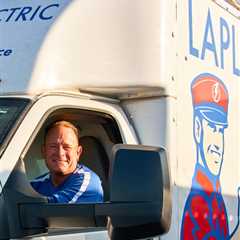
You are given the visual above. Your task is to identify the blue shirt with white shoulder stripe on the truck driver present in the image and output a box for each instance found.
[31,165,103,203]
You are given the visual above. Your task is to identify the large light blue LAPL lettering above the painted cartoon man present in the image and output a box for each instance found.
[188,0,240,76]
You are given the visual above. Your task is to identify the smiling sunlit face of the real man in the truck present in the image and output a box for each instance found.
[43,126,82,175]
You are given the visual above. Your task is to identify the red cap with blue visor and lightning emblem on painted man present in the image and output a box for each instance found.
[191,74,228,125]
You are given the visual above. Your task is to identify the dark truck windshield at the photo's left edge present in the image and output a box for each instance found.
[0,98,30,148]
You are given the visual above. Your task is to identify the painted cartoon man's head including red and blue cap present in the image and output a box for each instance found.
[191,74,228,176]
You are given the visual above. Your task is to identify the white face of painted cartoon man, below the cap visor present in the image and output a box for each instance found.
[202,119,224,175]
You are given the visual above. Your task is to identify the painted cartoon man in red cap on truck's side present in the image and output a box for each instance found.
[181,74,230,240]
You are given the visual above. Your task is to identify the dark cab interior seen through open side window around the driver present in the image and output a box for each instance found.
[23,108,122,201]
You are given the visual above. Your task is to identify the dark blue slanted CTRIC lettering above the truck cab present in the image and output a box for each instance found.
[0,3,60,22]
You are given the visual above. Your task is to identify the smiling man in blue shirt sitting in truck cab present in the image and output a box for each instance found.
[31,121,103,203]
